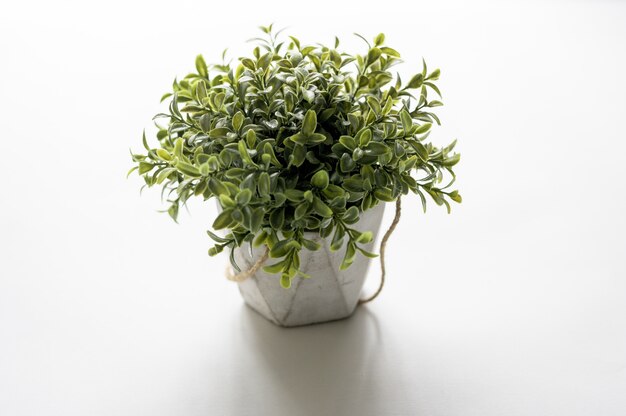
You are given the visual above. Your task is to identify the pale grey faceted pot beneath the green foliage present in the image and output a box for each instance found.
[235,203,385,327]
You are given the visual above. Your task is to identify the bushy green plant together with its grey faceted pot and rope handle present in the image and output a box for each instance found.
[131,25,461,326]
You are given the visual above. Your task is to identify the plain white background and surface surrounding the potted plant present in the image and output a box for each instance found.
[0,0,626,416]
